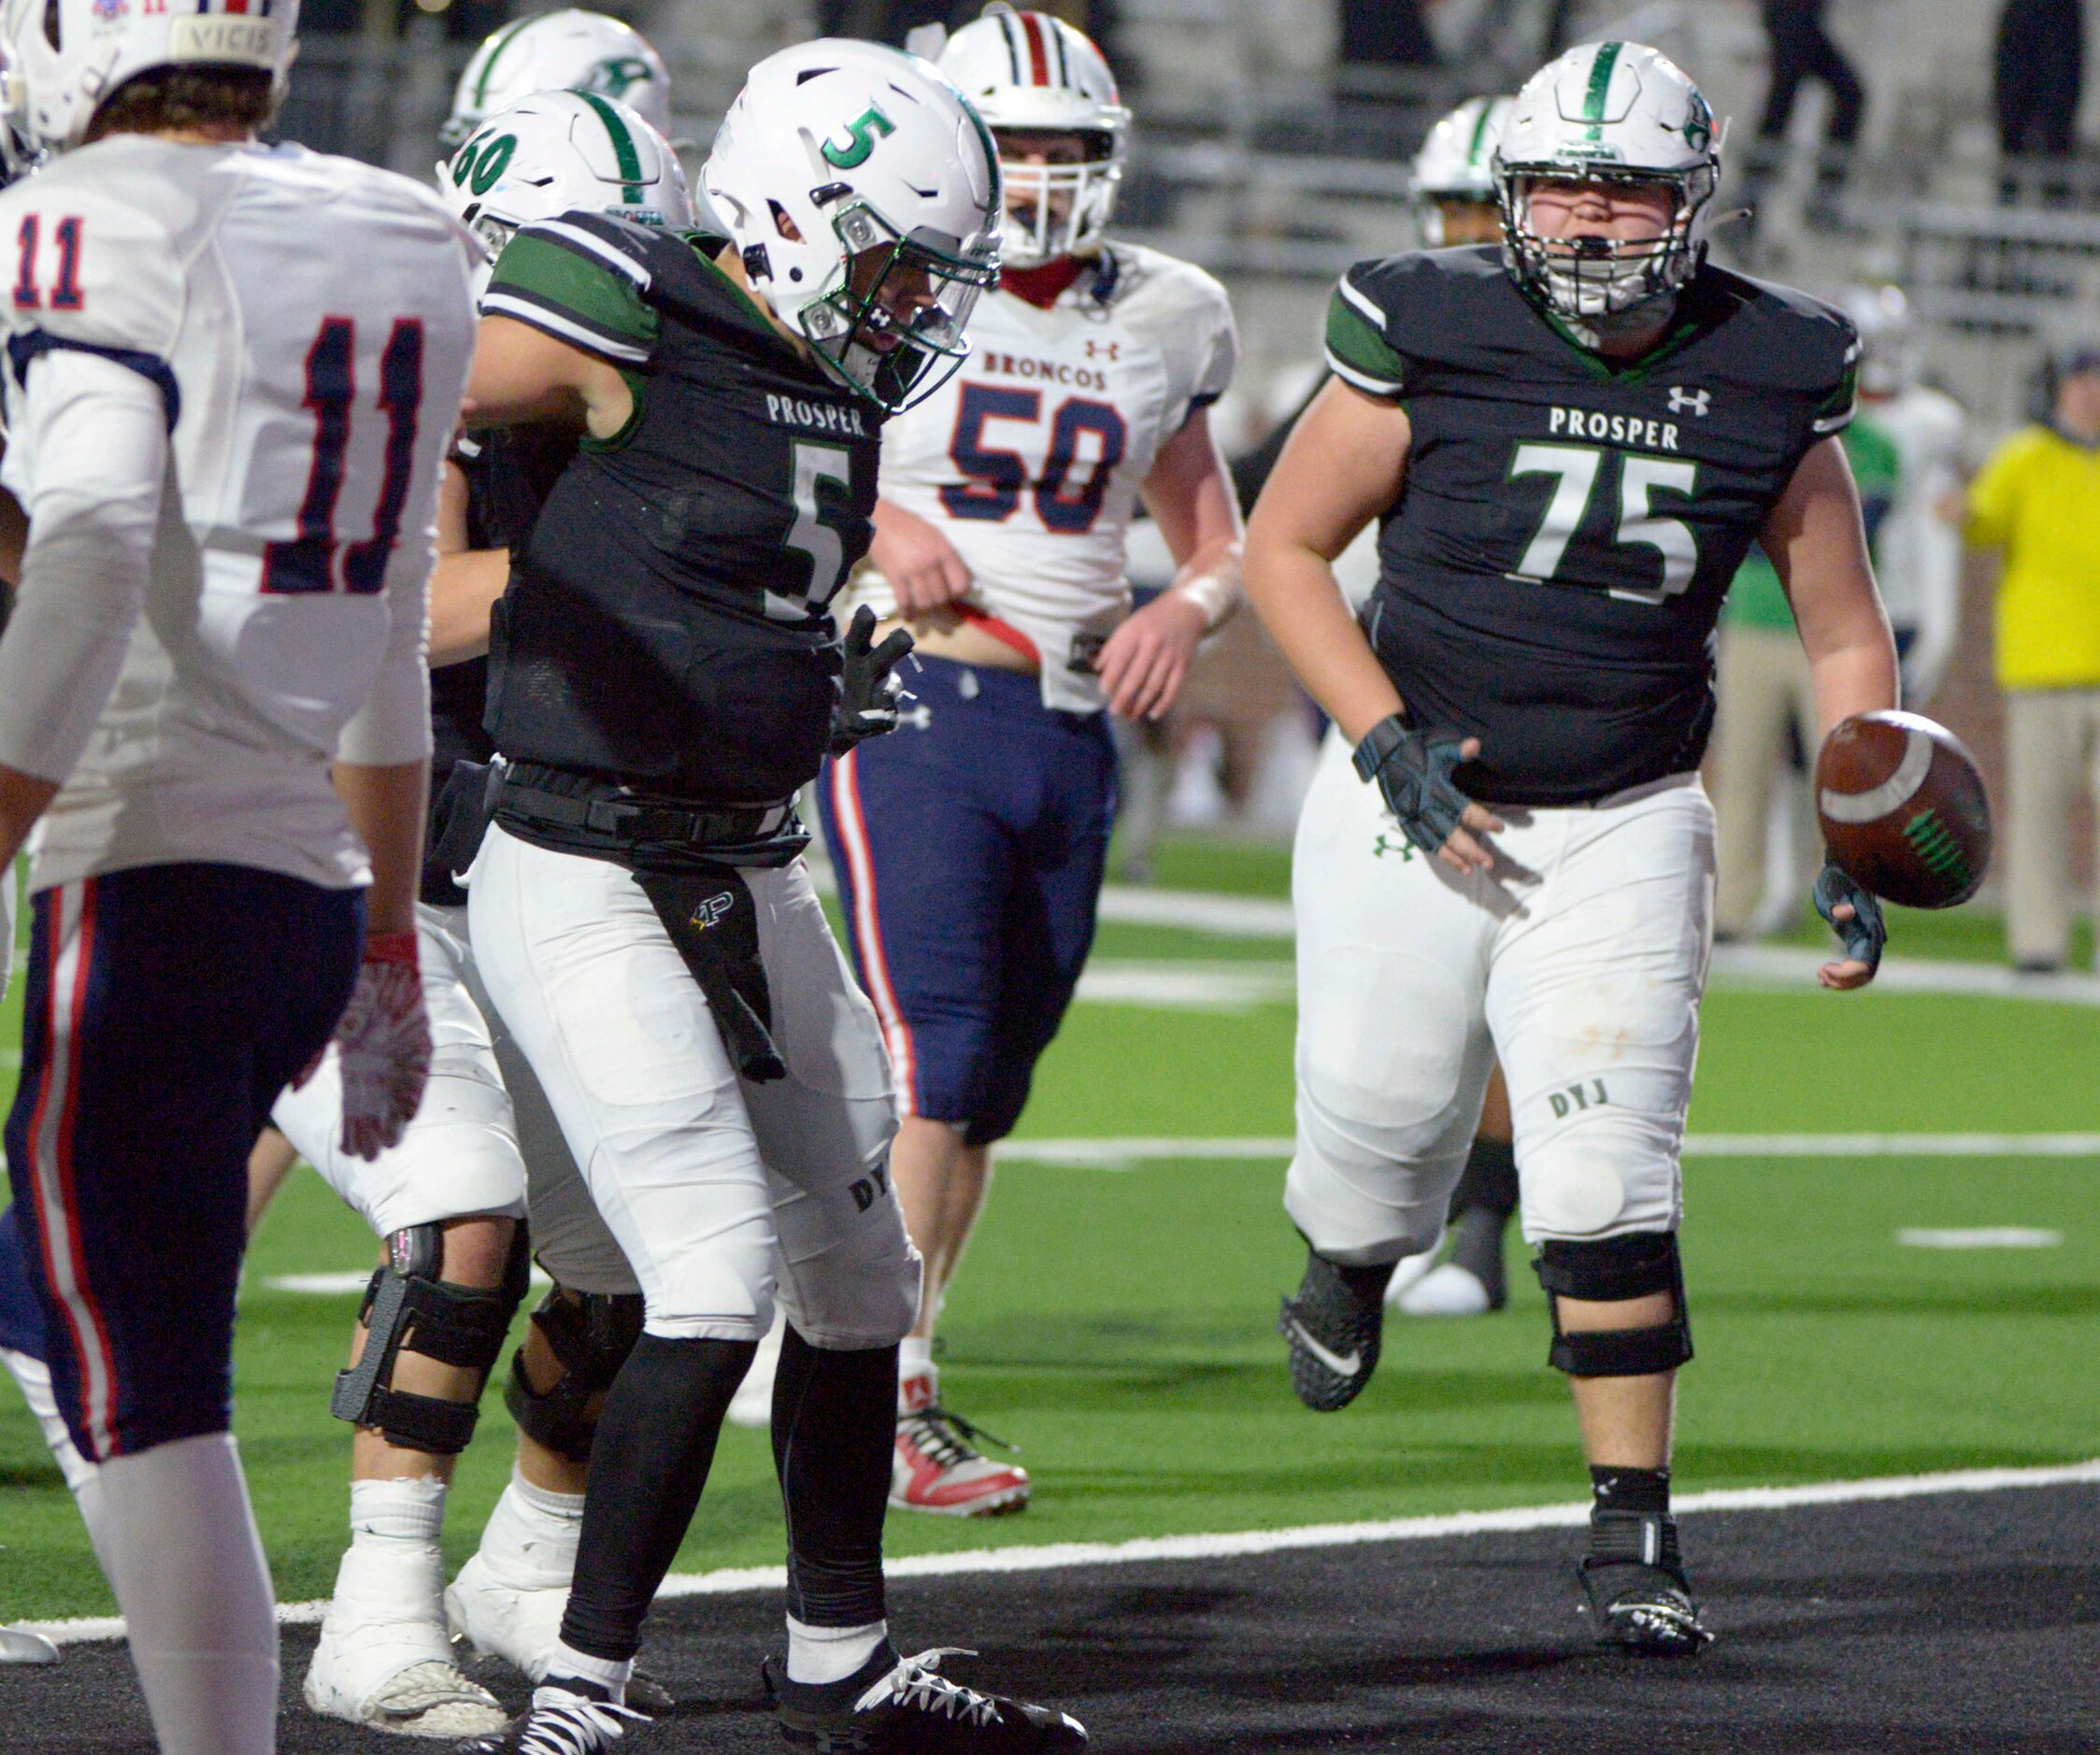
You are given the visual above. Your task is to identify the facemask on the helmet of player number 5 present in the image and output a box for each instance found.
[797,197,1000,414]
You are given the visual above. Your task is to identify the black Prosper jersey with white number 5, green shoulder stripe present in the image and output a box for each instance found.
[481,212,879,802]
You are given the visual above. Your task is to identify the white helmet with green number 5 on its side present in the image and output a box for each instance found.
[699,37,1000,414]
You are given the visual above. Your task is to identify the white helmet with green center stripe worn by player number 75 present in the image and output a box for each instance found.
[1495,42,1720,321]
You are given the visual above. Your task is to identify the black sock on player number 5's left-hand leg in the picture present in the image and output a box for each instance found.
[561,1333,758,1662]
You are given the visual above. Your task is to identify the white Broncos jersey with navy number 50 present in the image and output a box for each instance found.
[857,244,1239,712]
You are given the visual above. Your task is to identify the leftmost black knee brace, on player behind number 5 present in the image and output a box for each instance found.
[328,1224,531,1457]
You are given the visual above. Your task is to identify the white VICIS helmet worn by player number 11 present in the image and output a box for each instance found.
[0,0,298,153]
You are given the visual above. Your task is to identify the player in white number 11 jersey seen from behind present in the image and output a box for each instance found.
[0,0,473,1755]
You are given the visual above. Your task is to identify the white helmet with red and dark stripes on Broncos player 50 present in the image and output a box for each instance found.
[938,4,1130,269]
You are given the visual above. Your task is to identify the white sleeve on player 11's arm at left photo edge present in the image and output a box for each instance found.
[0,349,168,785]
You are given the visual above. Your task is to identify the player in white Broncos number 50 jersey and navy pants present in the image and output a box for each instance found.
[819,8,1239,1516]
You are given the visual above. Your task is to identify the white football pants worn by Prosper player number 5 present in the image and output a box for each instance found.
[468,825,920,1348]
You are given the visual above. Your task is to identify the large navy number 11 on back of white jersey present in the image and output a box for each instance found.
[263,317,422,596]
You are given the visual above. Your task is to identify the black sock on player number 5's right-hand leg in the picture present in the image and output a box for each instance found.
[773,1322,896,1627]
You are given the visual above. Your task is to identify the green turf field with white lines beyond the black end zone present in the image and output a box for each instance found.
[0,844,2100,1619]
